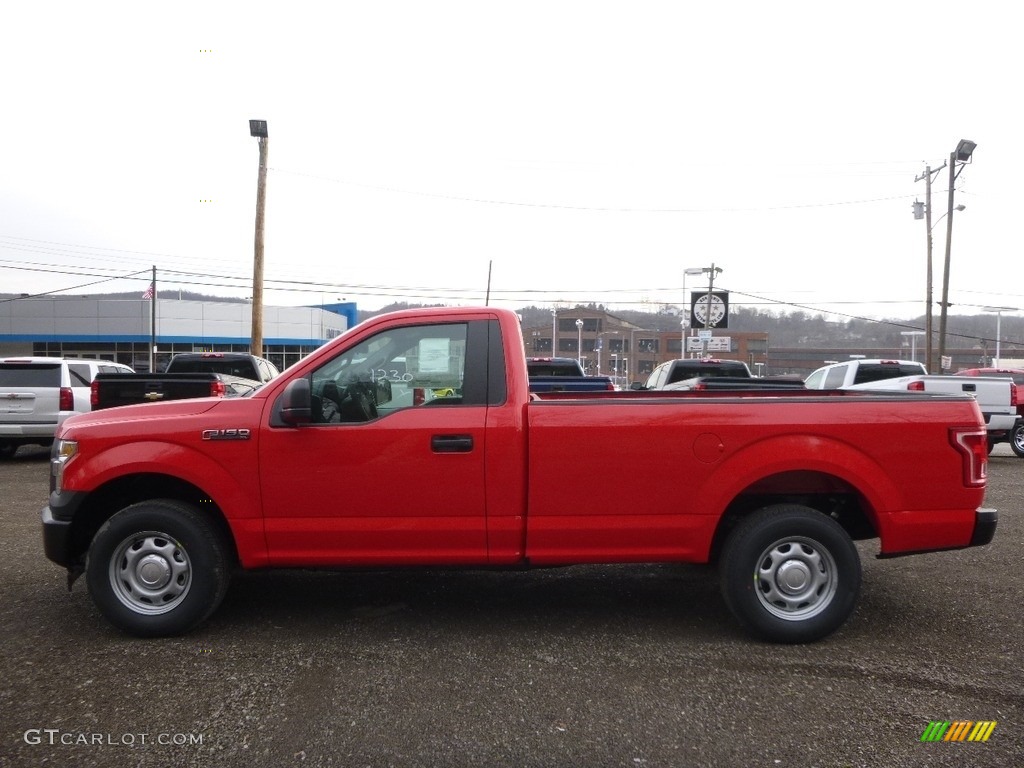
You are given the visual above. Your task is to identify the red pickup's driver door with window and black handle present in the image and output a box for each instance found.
[259,322,487,565]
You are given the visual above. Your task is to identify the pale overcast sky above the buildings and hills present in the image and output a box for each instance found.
[0,0,1024,317]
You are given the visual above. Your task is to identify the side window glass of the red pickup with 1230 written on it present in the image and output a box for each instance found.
[310,324,466,424]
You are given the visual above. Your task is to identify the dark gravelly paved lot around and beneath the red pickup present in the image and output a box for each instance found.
[0,445,1024,768]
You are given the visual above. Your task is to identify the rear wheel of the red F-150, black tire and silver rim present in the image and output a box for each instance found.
[719,504,860,643]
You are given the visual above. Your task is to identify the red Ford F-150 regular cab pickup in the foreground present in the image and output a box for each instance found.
[43,308,997,642]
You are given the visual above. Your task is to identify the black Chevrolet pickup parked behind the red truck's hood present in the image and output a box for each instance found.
[90,352,279,411]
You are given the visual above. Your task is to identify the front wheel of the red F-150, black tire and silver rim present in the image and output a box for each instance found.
[86,499,230,637]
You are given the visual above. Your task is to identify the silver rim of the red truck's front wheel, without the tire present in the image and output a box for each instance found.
[110,530,191,615]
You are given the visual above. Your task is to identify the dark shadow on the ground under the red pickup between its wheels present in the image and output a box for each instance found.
[214,564,739,639]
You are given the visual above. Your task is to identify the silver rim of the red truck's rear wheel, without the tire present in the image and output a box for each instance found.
[754,537,839,622]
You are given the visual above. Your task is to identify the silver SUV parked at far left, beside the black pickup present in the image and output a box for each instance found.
[0,357,133,459]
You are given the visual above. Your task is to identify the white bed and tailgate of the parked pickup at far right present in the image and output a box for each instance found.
[844,376,1020,451]
